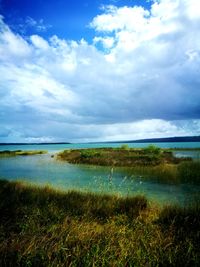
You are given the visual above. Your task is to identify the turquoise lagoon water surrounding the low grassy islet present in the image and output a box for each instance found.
[0,143,200,207]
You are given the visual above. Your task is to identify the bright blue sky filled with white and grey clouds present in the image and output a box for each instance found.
[0,0,200,142]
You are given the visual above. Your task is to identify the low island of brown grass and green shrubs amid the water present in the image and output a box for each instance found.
[58,145,191,167]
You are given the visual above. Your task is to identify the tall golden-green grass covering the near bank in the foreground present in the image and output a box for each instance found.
[0,181,200,266]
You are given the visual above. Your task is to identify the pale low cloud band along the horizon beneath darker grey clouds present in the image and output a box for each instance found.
[0,117,200,142]
